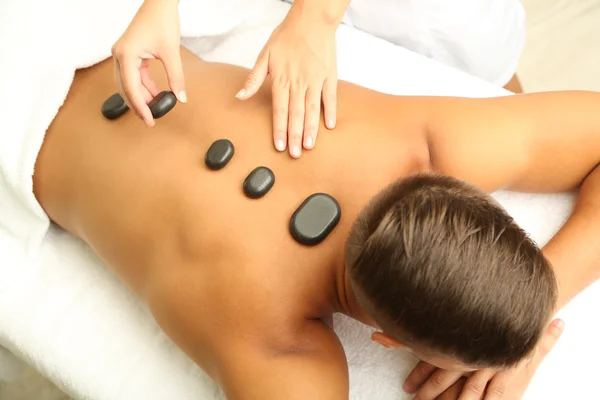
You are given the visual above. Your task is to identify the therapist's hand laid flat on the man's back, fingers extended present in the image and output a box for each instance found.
[236,7,337,158]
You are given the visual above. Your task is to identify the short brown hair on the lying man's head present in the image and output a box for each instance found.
[346,174,557,367]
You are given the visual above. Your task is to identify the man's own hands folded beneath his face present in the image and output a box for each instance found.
[404,319,564,400]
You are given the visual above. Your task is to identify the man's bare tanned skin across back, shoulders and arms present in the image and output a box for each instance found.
[34,49,600,400]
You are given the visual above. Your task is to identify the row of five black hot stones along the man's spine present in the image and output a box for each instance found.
[102,91,341,246]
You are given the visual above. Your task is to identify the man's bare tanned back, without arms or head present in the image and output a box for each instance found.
[35,47,427,394]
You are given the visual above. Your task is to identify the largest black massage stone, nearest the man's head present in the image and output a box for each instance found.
[290,193,342,246]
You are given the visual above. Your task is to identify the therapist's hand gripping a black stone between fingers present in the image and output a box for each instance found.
[112,0,187,126]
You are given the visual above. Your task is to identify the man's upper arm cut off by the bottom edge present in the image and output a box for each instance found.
[218,322,349,400]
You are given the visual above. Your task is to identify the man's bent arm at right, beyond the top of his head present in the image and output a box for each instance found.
[423,92,600,308]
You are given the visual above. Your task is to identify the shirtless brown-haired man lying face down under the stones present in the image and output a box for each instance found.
[34,49,600,400]
